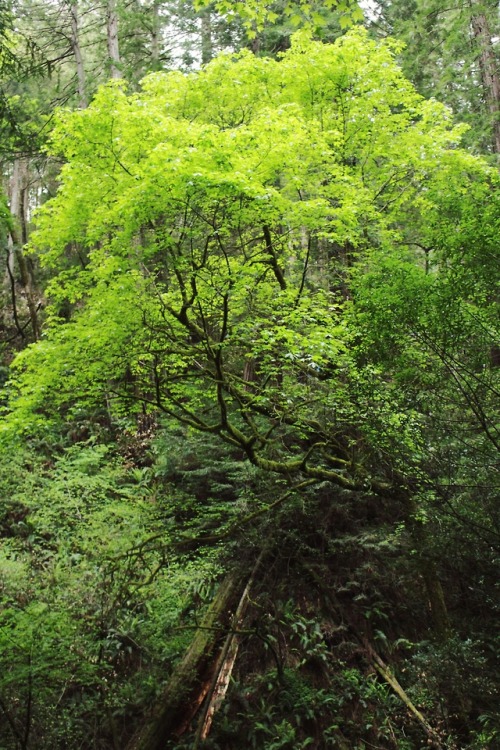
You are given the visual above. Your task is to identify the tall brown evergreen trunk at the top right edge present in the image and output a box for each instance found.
[471,2,500,154]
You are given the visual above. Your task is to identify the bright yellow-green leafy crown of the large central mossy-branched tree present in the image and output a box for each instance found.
[4,31,480,484]
